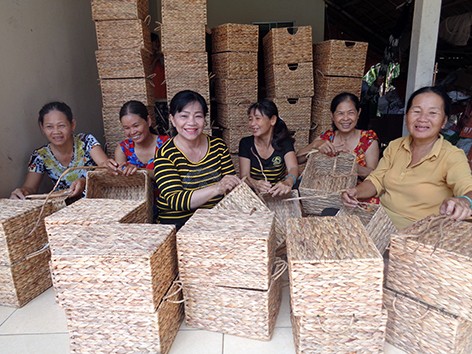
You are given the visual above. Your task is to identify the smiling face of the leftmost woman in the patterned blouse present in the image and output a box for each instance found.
[41,110,75,146]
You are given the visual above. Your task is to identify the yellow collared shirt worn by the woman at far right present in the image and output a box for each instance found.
[366,136,472,229]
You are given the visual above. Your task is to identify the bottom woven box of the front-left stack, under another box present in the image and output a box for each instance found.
[65,276,183,354]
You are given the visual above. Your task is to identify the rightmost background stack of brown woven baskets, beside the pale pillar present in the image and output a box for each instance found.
[310,40,367,141]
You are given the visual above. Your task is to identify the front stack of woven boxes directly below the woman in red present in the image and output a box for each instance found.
[287,216,387,354]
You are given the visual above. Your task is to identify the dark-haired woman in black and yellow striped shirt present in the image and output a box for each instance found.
[154,90,240,228]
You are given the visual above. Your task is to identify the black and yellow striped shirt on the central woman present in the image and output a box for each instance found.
[154,136,235,228]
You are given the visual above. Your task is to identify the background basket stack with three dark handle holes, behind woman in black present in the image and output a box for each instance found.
[263,26,313,149]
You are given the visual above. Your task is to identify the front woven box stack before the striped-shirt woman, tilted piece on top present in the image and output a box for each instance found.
[177,183,286,340]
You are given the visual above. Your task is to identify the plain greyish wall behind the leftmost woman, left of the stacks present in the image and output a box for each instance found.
[0,0,104,197]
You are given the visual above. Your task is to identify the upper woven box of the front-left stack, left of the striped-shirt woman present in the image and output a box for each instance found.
[48,224,178,313]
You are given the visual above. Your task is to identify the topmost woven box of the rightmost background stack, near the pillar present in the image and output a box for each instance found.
[313,40,368,77]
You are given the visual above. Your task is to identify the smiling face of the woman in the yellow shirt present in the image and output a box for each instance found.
[406,92,446,141]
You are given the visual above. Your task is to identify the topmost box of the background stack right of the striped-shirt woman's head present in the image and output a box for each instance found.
[211,23,259,53]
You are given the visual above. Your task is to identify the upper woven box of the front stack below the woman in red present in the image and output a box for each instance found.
[287,216,383,317]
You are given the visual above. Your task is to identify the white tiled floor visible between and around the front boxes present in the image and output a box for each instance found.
[0,287,404,354]
